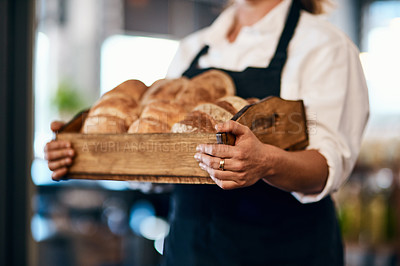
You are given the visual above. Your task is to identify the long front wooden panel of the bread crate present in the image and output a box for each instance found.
[57,133,217,180]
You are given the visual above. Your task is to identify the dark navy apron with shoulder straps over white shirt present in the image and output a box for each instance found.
[163,0,343,266]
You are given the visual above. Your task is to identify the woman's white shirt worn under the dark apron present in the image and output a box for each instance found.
[167,0,369,203]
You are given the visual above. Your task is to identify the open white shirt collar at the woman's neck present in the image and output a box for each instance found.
[204,0,292,46]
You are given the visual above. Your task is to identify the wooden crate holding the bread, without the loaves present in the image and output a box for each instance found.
[56,97,308,184]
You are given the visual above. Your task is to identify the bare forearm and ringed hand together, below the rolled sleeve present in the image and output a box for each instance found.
[195,121,329,194]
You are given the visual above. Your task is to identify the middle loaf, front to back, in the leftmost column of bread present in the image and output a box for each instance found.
[88,98,140,128]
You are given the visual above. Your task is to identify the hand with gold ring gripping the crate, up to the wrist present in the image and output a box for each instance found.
[194,120,280,189]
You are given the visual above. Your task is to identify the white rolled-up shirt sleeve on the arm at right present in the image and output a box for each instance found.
[292,39,369,203]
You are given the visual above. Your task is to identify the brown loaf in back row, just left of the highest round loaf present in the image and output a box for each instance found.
[142,77,189,105]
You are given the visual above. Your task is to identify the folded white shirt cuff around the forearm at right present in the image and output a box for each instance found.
[292,145,343,204]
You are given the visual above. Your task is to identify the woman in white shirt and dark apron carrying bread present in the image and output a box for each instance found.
[47,0,368,265]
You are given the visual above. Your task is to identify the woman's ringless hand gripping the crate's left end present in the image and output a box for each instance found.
[44,121,75,181]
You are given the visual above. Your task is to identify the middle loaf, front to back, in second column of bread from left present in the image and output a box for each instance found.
[140,100,186,127]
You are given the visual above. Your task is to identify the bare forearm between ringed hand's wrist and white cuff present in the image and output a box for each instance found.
[263,146,329,194]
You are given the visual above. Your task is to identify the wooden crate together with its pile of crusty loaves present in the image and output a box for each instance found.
[57,70,308,184]
